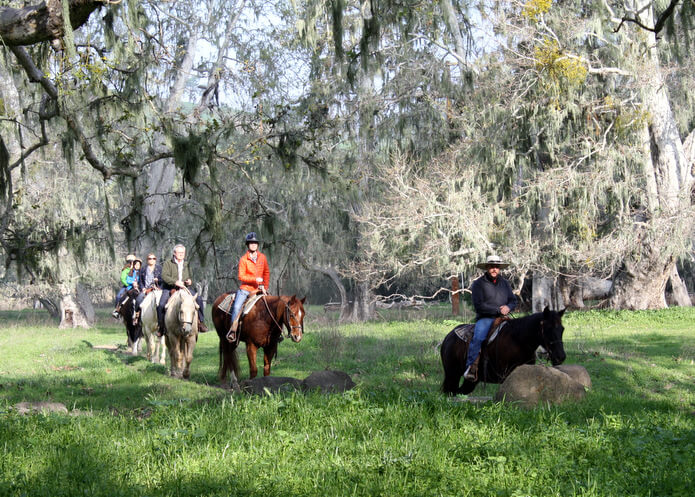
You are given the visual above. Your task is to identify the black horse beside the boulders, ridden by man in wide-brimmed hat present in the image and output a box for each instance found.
[440,307,565,395]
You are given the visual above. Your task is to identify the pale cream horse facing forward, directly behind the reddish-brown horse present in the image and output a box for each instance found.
[164,289,198,379]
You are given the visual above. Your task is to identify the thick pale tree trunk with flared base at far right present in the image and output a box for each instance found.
[610,0,693,309]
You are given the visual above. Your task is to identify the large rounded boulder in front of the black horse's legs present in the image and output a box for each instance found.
[495,365,588,408]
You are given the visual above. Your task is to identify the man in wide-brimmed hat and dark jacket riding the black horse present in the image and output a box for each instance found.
[463,255,517,381]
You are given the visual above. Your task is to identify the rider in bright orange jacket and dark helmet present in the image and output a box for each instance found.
[227,231,270,342]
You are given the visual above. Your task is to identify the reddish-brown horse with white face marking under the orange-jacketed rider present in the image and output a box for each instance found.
[212,293,306,389]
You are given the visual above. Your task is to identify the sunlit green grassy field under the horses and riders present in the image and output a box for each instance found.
[0,307,695,497]
